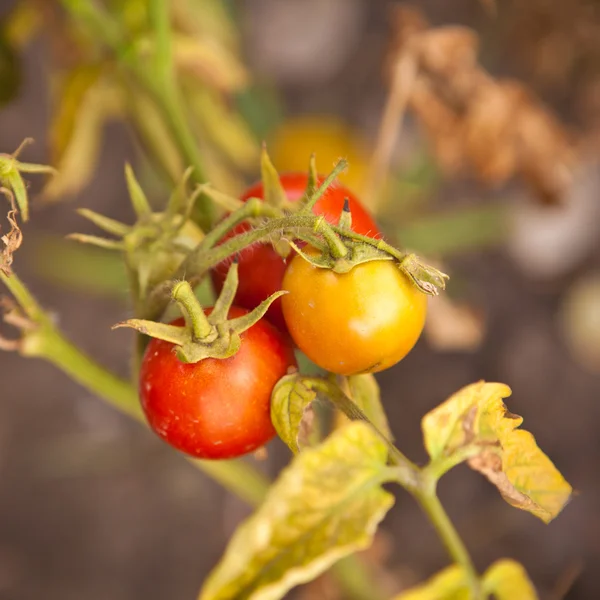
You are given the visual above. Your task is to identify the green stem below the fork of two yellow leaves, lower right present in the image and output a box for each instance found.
[413,476,481,600]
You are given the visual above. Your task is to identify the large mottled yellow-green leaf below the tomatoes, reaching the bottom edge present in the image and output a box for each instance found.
[200,423,393,600]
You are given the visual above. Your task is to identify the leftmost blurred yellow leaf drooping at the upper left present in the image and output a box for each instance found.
[43,68,122,200]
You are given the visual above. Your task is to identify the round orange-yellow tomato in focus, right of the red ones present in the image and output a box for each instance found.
[282,256,427,375]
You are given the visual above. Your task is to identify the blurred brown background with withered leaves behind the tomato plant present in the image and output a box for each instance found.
[0,0,600,600]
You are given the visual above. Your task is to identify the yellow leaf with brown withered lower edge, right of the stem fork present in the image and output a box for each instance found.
[422,382,572,523]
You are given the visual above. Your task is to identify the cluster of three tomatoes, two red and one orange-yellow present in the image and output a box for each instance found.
[140,173,427,459]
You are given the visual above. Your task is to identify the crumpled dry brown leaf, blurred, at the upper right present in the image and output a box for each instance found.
[388,6,577,204]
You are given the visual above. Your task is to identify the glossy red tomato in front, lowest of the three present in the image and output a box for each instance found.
[139,306,296,459]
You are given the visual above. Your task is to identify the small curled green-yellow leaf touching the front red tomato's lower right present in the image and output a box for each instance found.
[271,373,317,454]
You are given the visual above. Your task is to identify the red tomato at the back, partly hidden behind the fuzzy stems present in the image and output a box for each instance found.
[211,173,380,331]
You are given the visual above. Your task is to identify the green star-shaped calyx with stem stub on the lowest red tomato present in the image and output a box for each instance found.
[113,261,286,363]
